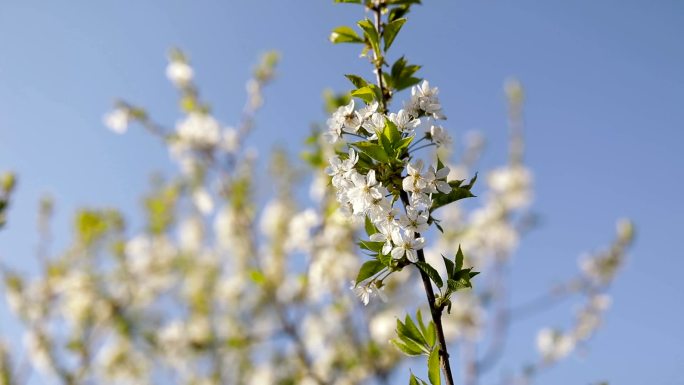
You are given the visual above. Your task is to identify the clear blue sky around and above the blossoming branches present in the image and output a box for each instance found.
[0,0,684,384]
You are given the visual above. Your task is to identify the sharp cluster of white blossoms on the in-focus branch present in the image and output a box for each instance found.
[327,81,464,304]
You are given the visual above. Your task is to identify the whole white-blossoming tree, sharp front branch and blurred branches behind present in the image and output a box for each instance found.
[0,0,634,385]
